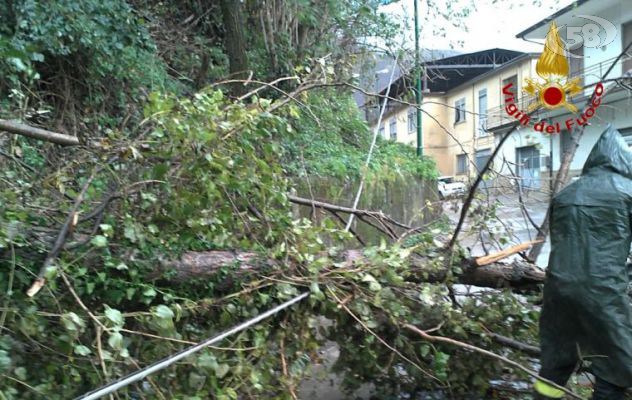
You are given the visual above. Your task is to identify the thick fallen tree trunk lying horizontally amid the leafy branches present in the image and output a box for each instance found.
[162,250,545,289]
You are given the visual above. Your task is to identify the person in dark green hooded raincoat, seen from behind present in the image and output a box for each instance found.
[535,127,632,400]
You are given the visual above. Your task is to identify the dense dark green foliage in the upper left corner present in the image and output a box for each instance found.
[0,0,169,128]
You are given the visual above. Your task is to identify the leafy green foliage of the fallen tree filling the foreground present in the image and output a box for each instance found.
[0,91,534,399]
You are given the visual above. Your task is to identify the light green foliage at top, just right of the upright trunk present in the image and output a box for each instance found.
[246,0,400,79]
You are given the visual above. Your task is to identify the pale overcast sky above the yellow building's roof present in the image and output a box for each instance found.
[383,0,573,52]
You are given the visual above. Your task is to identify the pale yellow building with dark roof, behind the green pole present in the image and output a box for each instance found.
[367,49,539,178]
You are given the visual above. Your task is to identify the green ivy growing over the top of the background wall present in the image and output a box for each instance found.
[283,89,436,180]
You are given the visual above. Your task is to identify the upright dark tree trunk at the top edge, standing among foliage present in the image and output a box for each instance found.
[220,0,248,95]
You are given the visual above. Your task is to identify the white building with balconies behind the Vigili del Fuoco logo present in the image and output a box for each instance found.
[487,0,632,188]
